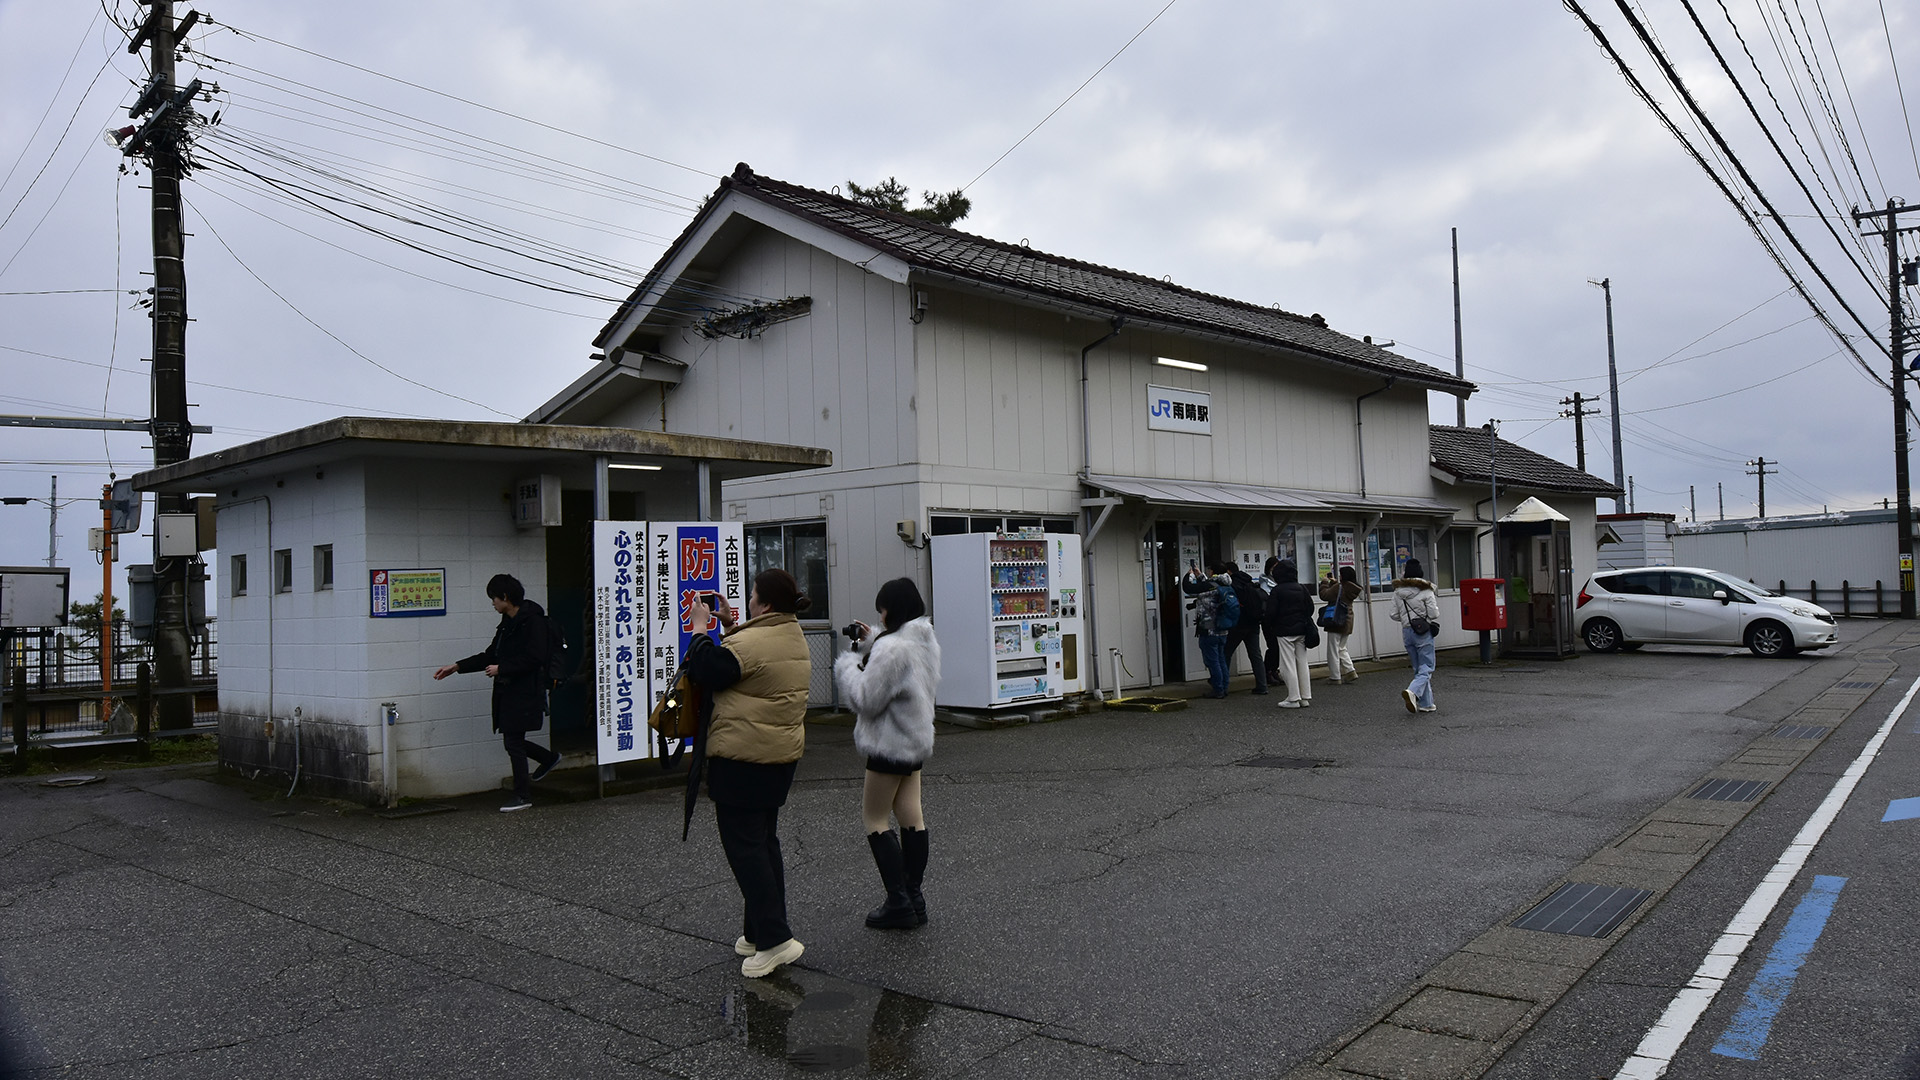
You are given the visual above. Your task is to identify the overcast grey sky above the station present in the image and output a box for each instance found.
[0,0,1920,580]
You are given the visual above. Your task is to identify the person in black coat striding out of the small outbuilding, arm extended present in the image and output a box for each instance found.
[434,575,561,813]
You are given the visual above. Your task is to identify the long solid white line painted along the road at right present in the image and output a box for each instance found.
[1615,678,1920,1080]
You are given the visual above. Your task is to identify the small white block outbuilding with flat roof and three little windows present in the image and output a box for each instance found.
[134,417,831,803]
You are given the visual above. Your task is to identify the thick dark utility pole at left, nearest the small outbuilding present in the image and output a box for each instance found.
[121,0,200,728]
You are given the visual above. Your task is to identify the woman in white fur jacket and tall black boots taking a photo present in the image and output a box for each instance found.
[833,578,941,930]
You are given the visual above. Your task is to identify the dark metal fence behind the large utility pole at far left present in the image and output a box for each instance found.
[0,621,219,751]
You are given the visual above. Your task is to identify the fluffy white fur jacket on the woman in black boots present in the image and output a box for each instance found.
[833,617,941,761]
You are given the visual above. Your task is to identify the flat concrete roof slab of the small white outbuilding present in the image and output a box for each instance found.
[132,417,833,492]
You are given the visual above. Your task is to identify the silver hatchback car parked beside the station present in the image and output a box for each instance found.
[1574,567,1834,657]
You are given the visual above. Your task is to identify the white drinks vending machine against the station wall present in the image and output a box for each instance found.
[933,528,1087,709]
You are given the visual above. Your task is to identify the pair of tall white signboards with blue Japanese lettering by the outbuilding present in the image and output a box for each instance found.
[593,521,747,765]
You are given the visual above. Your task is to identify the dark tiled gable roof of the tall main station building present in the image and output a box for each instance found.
[601,163,1473,394]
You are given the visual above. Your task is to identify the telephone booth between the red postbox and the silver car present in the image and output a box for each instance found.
[1494,498,1576,659]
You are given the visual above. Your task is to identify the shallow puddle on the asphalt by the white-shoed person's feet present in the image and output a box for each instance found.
[720,969,935,1078]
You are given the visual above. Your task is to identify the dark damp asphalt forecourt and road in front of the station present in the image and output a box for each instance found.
[0,623,1920,1080]
